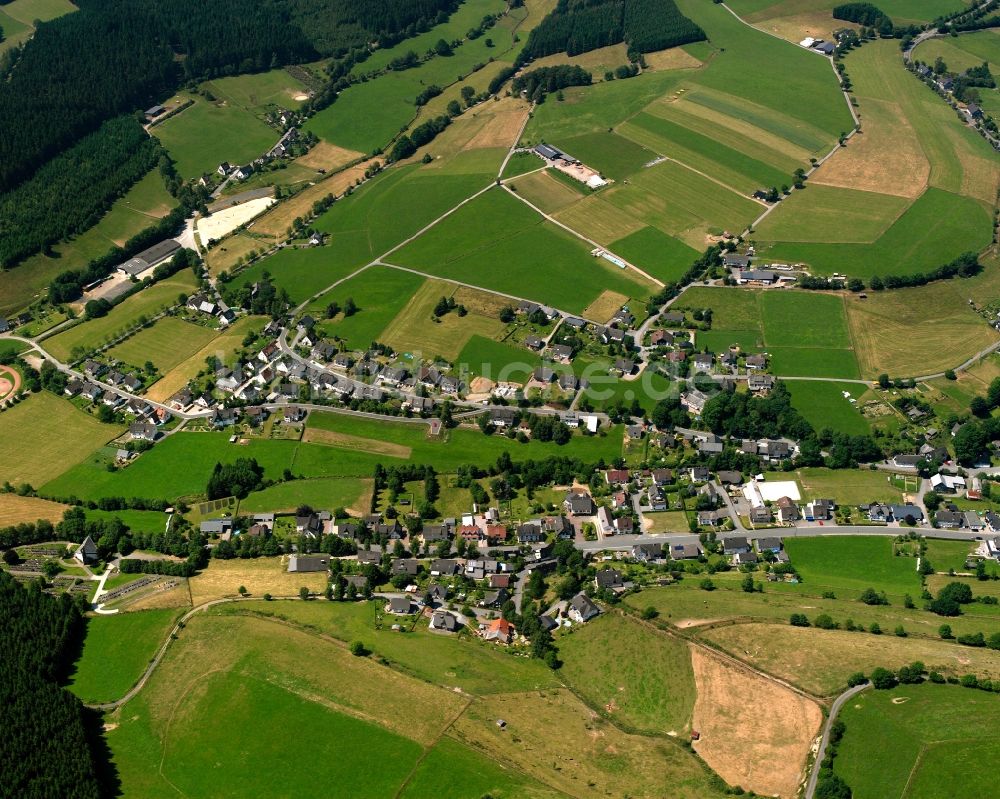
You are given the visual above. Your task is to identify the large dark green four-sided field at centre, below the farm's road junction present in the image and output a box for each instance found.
[392,189,652,313]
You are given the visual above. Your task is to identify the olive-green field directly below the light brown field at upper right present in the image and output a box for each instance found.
[755,184,910,244]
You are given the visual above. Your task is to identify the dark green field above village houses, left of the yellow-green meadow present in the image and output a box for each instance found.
[309,266,430,349]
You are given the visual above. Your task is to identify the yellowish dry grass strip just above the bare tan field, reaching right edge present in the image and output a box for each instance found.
[700,624,1000,696]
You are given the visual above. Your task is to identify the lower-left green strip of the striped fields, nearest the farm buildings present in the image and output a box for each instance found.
[622,112,791,194]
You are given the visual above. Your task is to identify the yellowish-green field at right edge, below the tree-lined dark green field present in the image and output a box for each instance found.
[846,280,997,377]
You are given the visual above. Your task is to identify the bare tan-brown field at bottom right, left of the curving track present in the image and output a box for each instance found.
[691,648,823,797]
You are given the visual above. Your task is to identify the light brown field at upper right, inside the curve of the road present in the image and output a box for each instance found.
[809,98,931,199]
